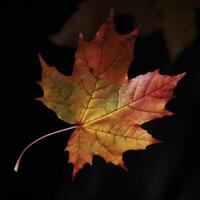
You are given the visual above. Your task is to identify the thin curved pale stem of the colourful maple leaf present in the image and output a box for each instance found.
[14,126,78,172]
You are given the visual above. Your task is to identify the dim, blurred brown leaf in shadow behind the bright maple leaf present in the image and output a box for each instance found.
[49,0,200,60]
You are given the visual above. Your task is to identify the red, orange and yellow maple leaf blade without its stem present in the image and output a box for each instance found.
[39,14,184,176]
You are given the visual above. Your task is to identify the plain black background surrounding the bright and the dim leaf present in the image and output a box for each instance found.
[1,1,200,200]
